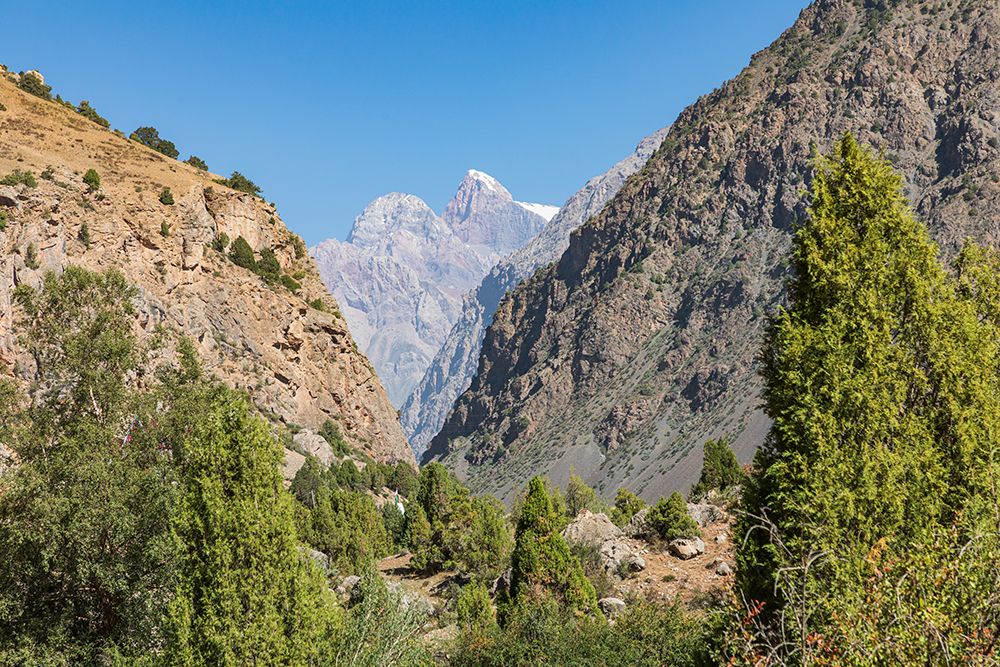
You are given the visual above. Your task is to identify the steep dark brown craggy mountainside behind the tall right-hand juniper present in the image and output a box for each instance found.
[428,0,1000,498]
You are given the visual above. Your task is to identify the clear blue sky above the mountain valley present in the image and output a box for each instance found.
[0,0,807,244]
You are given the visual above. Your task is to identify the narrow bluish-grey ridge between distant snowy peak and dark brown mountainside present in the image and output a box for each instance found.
[400,129,667,456]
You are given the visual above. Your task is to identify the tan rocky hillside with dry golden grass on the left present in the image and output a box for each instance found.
[0,72,413,461]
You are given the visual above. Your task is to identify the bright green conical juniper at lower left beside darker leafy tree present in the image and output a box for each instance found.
[167,385,333,665]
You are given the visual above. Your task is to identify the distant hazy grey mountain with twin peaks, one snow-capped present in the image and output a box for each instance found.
[311,170,558,405]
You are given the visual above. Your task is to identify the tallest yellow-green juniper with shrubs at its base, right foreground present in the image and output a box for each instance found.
[733,137,1000,664]
